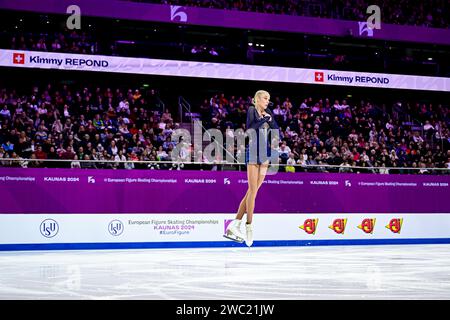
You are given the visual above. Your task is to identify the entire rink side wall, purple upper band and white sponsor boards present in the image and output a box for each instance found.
[0,168,450,250]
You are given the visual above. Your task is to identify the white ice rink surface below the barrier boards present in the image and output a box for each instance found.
[0,245,450,300]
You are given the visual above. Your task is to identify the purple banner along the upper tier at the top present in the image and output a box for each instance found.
[0,0,450,45]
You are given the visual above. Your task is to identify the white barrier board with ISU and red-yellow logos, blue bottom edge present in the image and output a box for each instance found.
[0,213,450,251]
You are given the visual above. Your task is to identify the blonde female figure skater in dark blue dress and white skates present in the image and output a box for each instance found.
[224,90,278,247]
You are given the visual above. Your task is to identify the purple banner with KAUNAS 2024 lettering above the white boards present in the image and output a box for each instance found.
[0,168,450,214]
